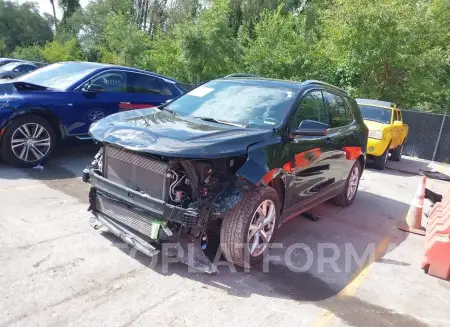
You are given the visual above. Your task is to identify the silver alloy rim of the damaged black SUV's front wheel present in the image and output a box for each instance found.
[247,200,276,257]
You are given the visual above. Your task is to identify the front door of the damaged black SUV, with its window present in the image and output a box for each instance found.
[282,90,340,211]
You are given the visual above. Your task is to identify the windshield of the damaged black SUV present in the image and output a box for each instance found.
[166,80,297,129]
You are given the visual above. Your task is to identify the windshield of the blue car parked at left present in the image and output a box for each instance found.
[16,62,96,90]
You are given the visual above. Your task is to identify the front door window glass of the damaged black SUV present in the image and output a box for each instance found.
[295,91,330,127]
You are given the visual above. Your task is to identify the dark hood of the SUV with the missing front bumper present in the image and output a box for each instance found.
[89,109,274,158]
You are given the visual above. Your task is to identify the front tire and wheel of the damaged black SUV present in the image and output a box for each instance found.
[220,186,280,268]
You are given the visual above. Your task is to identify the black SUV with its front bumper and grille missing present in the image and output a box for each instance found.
[83,77,368,272]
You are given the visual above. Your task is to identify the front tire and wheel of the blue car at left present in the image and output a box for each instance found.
[1,116,56,168]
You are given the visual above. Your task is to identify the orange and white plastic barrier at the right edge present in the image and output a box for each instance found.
[422,190,450,280]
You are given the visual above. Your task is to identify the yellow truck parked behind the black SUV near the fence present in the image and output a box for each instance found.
[356,99,408,170]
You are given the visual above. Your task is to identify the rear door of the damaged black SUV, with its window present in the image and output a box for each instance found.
[323,90,363,184]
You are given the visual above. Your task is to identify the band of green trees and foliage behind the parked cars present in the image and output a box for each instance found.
[0,0,450,113]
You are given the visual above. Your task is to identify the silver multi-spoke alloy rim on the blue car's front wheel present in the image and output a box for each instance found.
[11,123,51,162]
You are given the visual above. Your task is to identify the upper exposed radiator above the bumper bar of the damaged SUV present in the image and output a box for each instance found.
[104,146,168,200]
